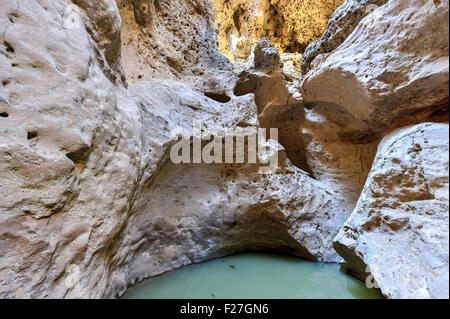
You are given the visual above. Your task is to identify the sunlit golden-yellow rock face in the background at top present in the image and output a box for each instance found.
[214,0,344,61]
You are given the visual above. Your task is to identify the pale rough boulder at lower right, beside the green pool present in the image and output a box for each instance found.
[334,123,449,298]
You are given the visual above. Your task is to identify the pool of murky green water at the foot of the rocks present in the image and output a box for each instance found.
[123,253,383,299]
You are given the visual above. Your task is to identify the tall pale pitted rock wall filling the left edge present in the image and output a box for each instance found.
[0,0,146,298]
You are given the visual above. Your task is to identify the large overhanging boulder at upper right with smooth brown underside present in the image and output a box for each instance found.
[302,0,449,142]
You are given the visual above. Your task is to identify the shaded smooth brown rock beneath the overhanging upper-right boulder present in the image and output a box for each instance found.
[300,105,378,204]
